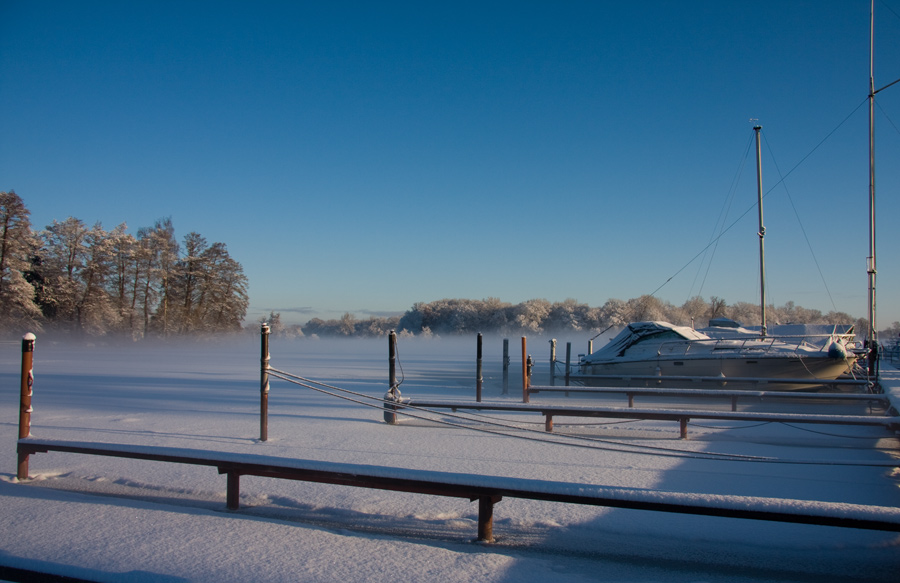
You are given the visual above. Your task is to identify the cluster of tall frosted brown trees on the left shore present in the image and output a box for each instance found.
[0,190,249,339]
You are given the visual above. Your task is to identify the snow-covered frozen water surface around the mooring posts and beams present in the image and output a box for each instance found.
[0,337,900,583]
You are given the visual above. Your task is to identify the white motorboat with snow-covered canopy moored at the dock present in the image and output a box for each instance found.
[570,321,856,390]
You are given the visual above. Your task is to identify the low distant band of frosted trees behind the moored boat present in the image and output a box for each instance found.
[264,295,867,336]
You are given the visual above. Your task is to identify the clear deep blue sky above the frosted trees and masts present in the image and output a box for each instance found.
[0,0,900,328]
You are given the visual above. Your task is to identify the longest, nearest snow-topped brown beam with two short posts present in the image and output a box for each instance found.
[18,438,900,542]
